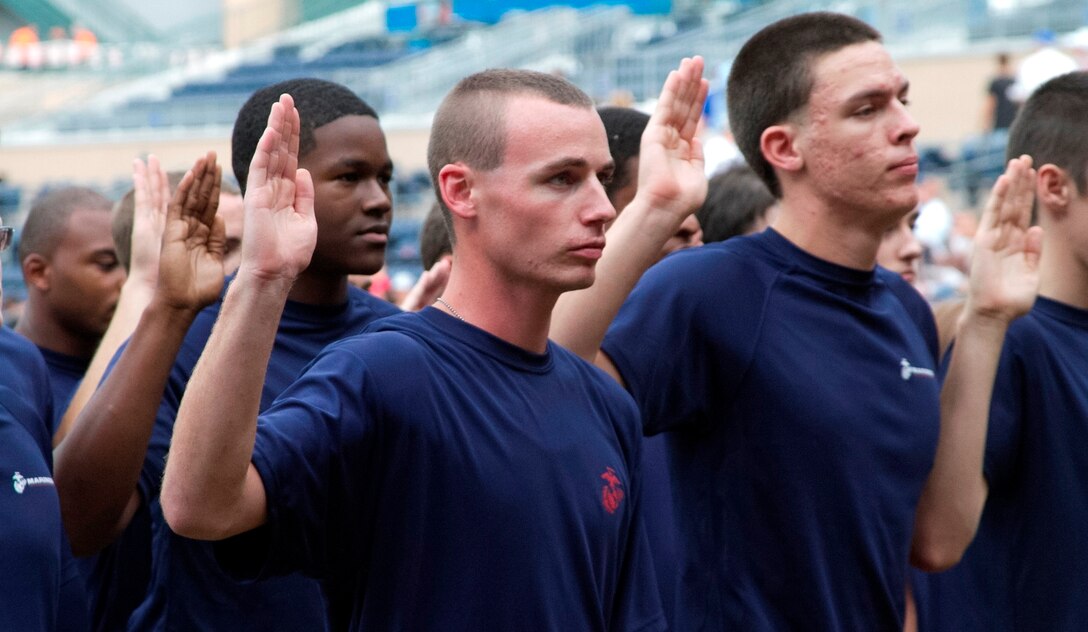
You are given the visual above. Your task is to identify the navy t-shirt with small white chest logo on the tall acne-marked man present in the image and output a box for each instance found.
[603,230,940,630]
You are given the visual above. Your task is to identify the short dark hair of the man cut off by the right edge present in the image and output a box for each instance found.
[1005,71,1088,196]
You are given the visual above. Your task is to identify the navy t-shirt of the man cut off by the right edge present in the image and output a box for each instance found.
[918,297,1088,632]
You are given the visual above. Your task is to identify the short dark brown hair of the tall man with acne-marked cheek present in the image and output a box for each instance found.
[726,12,880,198]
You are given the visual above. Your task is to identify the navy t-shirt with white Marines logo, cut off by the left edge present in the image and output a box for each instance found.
[0,325,64,632]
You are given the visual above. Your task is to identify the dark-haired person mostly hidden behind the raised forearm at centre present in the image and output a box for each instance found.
[597,108,703,257]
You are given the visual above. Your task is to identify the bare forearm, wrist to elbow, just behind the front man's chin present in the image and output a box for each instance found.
[548,198,679,362]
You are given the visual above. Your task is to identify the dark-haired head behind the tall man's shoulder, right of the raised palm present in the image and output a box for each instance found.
[695,163,777,244]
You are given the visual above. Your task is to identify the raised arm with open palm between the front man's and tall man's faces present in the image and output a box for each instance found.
[549,57,707,379]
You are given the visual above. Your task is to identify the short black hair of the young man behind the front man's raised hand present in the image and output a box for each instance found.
[231,78,378,195]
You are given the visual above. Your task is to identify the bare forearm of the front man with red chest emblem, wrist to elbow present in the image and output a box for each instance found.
[161,273,290,540]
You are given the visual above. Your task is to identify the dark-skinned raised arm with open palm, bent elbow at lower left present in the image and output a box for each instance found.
[53,152,224,555]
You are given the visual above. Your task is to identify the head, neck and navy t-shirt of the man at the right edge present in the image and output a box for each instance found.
[917,72,1088,632]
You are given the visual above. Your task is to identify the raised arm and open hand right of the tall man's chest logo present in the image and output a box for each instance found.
[911,157,1042,571]
